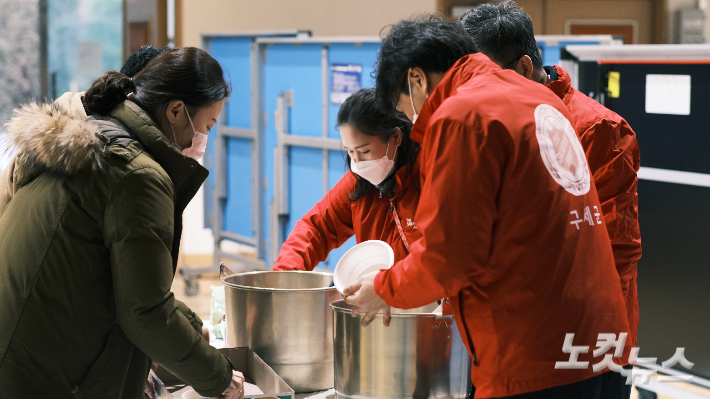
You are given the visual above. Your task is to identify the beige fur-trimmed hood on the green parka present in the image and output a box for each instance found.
[5,103,108,180]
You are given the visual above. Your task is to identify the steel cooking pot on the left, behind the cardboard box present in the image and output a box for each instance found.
[222,271,340,392]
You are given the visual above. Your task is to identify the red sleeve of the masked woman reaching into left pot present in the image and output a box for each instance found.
[274,172,356,270]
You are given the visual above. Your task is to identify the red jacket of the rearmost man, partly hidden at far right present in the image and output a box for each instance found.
[547,65,641,346]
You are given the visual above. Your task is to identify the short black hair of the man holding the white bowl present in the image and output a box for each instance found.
[373,15,476,112]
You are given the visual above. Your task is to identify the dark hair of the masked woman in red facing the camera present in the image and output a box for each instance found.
[337,89,419,201]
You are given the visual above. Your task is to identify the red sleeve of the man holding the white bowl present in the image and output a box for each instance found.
[375,119,510,309]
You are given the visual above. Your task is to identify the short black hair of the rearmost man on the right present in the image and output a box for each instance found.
[459,0,542,71]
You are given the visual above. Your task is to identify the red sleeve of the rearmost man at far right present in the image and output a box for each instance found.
[580,115,641,293]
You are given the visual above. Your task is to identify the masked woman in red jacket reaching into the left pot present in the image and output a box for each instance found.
[274,89,421,270]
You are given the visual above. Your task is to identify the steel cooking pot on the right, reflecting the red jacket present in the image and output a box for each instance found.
[330,300,471,399]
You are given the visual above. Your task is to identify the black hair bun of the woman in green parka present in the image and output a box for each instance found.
[84,71,135,115]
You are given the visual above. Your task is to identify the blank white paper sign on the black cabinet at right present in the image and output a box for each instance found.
[646,74,690,115]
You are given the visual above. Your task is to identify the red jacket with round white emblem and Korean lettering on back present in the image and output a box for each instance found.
[375,54,630,398]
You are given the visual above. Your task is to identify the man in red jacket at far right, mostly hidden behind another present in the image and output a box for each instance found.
[459,1,641,354]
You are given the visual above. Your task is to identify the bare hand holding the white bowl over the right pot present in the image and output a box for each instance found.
[343,271,392,327]
